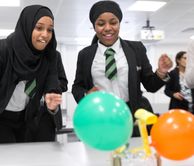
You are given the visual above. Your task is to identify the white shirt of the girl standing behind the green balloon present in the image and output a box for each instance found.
[91,39,129,101]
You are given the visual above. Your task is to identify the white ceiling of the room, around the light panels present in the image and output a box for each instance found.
[0,0,194,44]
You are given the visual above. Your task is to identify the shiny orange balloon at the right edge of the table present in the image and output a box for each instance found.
[150,109,194,160]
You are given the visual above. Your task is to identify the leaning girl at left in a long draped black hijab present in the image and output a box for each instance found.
[0,5,61,143]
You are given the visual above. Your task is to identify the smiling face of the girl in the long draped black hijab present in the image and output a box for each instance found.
[32,16,54,51]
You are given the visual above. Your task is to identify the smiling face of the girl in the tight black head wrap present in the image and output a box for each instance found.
[95,12,120,46]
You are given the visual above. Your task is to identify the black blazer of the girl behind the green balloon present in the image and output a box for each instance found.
[72,39,165,113]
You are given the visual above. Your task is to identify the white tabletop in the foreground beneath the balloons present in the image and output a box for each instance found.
[0,138,194,166]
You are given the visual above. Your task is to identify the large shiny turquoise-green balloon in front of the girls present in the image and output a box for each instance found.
[73,91,133,150]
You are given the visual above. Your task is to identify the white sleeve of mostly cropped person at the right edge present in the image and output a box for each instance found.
[185,41,194,88]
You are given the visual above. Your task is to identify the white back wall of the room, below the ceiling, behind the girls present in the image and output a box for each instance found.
[60,43,187,118]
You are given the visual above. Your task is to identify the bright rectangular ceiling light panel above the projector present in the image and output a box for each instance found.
[128,1,166,12]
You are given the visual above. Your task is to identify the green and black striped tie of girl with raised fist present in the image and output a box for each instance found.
[104,48,117,80]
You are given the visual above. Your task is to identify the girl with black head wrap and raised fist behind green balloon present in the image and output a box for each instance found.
[72,0,172,136]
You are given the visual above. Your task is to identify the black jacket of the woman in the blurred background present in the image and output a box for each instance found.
[164,68,194,110]
